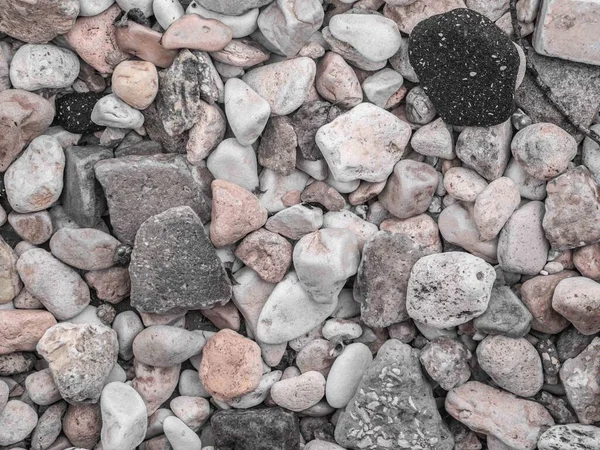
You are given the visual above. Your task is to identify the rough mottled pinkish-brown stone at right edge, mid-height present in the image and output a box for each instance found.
[543,166,600,250]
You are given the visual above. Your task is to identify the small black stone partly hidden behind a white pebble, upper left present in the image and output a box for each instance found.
[56,92,104,134]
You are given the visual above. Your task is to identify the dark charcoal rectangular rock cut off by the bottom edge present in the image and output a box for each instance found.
[210,408,300,450]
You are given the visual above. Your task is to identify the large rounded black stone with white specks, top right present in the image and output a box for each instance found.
[409,9,519,126]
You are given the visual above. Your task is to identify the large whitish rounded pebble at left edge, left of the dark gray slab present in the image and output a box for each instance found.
[4,136,65,213]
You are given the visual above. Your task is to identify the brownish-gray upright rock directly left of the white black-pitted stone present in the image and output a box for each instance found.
[354,231,432,328]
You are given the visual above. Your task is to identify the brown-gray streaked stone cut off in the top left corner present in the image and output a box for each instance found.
[0,0,79,44]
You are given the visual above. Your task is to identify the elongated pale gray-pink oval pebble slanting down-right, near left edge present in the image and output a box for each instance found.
[17,248,90,320]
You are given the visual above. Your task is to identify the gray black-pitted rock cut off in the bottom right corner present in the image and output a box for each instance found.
[538,423,600,450]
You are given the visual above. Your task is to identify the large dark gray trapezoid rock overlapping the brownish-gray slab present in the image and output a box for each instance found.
[129,206,231,314]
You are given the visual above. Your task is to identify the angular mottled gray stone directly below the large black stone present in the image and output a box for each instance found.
[456,120,513,181]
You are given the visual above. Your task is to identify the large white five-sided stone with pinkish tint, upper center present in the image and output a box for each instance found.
[316,103,410,182]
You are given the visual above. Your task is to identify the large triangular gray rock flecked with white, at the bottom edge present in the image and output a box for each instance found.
[335,339,454,450]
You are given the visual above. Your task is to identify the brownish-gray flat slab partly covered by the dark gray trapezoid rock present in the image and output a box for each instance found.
[95,154,212,245]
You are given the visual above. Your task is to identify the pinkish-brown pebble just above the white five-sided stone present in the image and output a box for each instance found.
[315,52,363,108]
